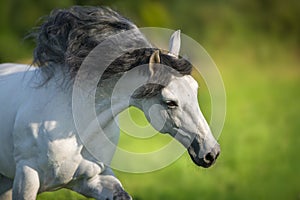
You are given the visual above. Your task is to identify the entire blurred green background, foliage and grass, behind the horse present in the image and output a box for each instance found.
[0,0,300,200]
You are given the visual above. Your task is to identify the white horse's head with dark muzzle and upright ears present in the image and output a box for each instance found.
[135,31,220,168]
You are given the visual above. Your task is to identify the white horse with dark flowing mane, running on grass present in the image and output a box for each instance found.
[0,7,220,200]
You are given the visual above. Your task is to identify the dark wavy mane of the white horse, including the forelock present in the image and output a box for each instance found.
[33,6,192,98]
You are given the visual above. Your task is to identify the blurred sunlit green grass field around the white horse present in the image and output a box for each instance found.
[38,41,300,200]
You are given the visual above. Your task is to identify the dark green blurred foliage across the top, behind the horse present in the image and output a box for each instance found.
[0,0,300,62]
